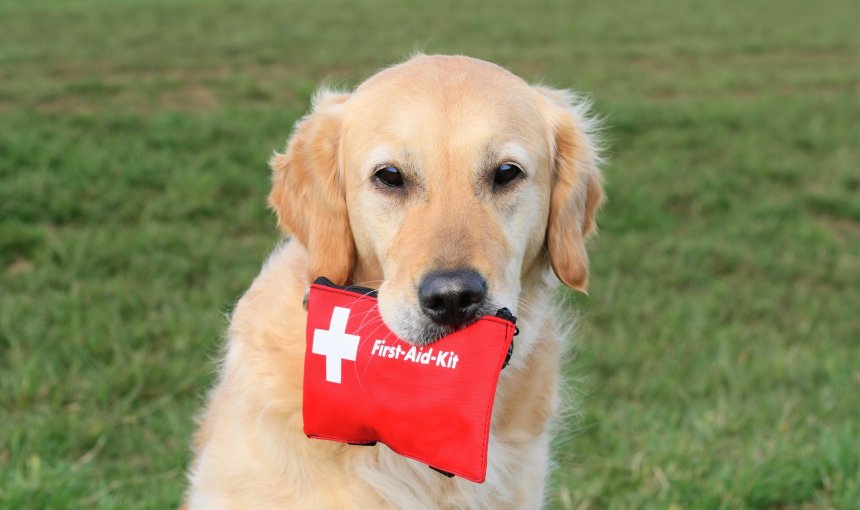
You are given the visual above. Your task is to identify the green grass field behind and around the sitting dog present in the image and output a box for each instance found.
[0,0,860,510]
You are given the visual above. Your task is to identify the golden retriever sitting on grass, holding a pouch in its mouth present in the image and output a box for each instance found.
[187,55,604,510]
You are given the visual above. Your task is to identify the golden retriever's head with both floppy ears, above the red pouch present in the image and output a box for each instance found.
[269,56,603,344]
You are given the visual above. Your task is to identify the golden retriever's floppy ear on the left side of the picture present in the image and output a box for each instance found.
[269,90,355,285]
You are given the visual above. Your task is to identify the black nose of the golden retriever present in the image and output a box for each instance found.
[418,269,487,327]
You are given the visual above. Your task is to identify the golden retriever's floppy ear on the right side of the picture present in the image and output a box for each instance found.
[535,87,604,292]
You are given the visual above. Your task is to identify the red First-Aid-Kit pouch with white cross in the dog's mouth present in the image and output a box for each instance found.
[302,278,517,483]
